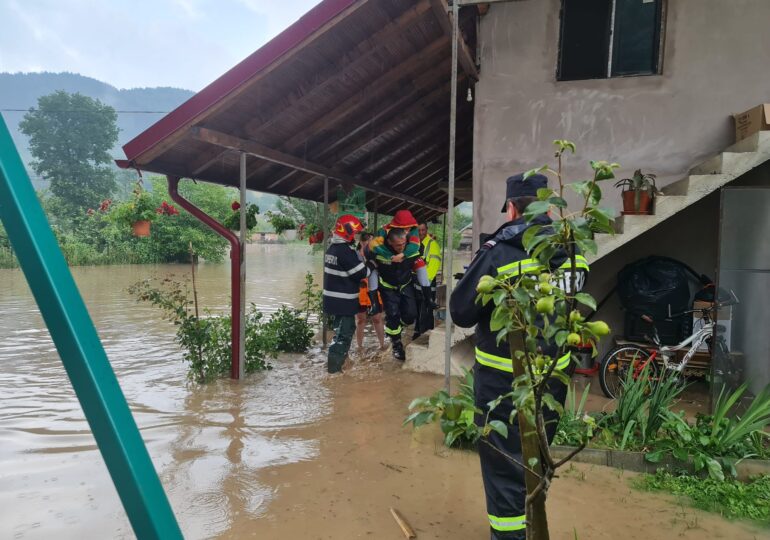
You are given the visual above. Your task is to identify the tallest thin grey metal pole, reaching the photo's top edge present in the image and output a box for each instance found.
[444,2,460,393]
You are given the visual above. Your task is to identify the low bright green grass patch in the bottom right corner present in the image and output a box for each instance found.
[633,471,770,527]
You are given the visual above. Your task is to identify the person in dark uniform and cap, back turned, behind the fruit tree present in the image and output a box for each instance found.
[449,174,588,540]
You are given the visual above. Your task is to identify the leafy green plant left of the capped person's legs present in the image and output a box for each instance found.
[404,369,481,448]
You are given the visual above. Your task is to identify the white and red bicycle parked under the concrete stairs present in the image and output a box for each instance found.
[599,291,738,399]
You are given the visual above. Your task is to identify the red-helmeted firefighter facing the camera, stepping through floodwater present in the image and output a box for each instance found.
[367,227,430,362]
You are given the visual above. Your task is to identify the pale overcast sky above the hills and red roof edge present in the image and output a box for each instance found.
[0,0,319,91]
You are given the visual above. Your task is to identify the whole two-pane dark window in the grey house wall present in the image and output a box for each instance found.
[558,0,664,81]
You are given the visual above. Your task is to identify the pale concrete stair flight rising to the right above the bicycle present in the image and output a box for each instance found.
[589,131,770,262]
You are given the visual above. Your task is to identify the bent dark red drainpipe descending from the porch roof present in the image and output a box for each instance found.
[166,176,241,379]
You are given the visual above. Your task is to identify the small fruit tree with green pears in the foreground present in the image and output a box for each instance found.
[477,140,619,540]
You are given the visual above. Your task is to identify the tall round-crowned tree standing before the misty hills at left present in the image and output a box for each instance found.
[19,91,118,214]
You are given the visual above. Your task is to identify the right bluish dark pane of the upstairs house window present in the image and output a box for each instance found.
[612,0,660,77]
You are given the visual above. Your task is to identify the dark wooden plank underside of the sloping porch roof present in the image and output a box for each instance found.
[121,0,475,215]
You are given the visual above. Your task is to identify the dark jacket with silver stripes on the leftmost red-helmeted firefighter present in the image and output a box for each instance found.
[323,236,369,315]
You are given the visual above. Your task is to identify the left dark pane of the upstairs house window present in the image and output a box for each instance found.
[559,0,612,81]
